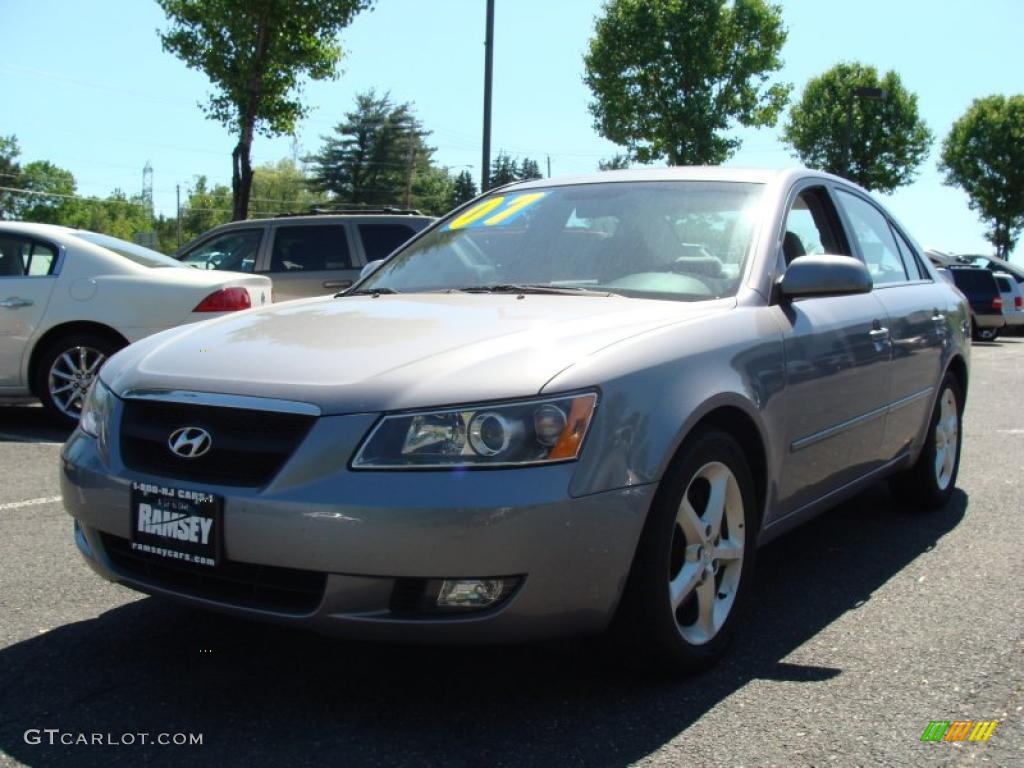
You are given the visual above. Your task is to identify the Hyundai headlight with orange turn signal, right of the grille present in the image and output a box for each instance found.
[352,392,597,469]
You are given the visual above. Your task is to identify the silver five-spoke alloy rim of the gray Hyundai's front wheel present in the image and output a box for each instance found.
[669,462,745,645]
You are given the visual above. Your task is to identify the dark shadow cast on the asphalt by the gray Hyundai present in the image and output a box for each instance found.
[0,484,968,767]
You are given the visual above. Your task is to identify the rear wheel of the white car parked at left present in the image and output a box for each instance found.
[34,333,125,426]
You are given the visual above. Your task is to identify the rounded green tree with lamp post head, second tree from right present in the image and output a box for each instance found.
[782,61,932,193]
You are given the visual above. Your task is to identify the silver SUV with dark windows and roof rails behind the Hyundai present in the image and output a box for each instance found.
[174,214,433,301]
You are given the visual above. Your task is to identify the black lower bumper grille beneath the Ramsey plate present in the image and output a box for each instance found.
[100,534,327,614]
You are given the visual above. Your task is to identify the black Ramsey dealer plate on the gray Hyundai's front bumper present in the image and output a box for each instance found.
[131,482,223,567]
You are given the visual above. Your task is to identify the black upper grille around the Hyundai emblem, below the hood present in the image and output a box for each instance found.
[121,399,315,486]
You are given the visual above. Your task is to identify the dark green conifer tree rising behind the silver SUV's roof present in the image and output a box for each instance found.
[306,90,434,206]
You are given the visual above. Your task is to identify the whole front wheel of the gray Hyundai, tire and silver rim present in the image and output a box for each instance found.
[615,430,758,674]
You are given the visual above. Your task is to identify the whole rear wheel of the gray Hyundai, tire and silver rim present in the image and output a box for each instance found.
[892,374,964,509]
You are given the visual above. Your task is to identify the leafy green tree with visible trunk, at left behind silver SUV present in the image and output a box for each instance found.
[157,0,372,219]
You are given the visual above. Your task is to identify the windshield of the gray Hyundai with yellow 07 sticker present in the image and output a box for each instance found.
[358,181,762,301]
